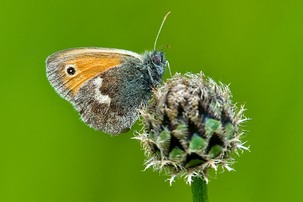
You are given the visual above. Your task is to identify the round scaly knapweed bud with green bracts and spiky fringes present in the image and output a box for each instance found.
[135,73,248,183]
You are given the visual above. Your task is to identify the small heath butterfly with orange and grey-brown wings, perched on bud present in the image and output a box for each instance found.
[46,12,170,135]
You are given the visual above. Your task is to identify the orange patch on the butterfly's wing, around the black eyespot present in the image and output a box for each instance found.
[64,54,122,95]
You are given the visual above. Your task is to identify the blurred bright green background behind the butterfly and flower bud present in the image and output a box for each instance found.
[0,0,303,202]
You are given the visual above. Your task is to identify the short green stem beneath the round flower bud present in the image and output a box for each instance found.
[191,177,208,202]
